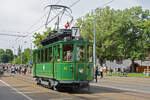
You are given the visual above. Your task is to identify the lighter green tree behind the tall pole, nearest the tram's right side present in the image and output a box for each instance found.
[76,7,123,62]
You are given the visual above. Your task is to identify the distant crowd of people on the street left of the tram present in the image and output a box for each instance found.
[0,64,32,75]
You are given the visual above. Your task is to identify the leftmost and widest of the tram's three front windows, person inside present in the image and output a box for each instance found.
[63,44,73,61]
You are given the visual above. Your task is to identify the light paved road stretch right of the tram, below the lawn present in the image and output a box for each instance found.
[91,77,150,94]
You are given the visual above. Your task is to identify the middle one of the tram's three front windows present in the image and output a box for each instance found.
[77,46,85,61]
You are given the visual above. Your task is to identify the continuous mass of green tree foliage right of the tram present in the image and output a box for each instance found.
[76,7,150,64]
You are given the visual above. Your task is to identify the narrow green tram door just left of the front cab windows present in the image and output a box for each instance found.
[53,45,60,79]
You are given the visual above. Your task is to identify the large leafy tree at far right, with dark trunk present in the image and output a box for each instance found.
[119,7,150,72]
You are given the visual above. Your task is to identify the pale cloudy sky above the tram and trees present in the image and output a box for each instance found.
[0,0,150,52]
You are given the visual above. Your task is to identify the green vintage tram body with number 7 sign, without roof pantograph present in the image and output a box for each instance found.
[33,29,94,90]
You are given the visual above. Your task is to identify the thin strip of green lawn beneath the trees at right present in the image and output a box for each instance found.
[104,73,150,78]
